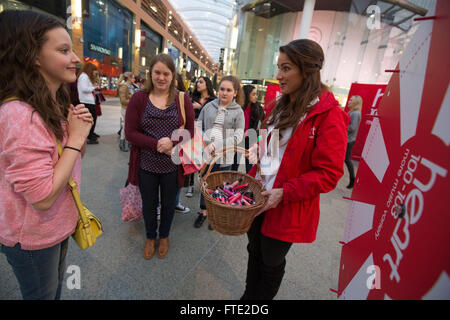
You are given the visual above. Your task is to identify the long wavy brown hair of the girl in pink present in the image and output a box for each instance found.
[0,10,70,139]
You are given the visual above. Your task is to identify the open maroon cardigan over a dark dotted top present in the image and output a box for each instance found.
[125,91,194,188]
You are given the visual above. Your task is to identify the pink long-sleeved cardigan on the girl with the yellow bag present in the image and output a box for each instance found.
[0,101,81,250]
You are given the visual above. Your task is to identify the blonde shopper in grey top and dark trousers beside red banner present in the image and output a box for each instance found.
[345,96,362,189]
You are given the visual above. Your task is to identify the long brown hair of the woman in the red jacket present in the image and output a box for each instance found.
[262,39,327,132]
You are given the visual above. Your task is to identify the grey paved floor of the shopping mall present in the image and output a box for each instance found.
[0,99,356,300]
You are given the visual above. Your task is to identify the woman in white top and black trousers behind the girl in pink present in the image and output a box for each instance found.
[77,62,100,144]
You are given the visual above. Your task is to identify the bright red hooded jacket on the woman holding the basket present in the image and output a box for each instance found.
[249,91,349,243]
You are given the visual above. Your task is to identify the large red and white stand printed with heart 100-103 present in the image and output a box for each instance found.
[337,0,450,299]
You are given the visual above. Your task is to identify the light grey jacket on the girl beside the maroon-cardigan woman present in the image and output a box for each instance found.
[197,99,245,148]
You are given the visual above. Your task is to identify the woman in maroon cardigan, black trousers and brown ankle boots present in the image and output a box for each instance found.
[125,54,194,259]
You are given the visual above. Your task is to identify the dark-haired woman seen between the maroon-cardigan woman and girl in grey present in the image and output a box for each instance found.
[185,77,217,198]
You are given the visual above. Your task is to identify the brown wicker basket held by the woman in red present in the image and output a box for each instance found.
[199,147,267,236]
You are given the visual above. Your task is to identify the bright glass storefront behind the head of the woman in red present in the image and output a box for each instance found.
[236,0,435,105]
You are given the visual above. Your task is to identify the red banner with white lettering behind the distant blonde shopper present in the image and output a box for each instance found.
[345,83,386,160]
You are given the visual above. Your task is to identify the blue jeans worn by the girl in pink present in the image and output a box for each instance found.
[1,239,68,300]
